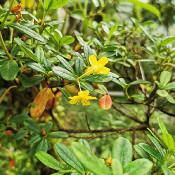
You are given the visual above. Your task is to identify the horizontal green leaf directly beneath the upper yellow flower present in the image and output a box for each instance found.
[81,74,112,83]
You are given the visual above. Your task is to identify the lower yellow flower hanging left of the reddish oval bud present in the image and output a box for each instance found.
[69,90,97,106]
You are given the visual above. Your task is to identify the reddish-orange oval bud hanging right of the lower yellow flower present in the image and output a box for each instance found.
[99,94,112,110]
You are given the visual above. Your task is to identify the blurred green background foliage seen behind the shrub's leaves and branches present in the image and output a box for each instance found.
[0,0,175,175]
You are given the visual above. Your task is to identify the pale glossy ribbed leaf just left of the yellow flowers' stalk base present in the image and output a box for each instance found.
[52,66,76,81]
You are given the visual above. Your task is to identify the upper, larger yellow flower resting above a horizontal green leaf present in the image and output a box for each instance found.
[85,55,110,75]
